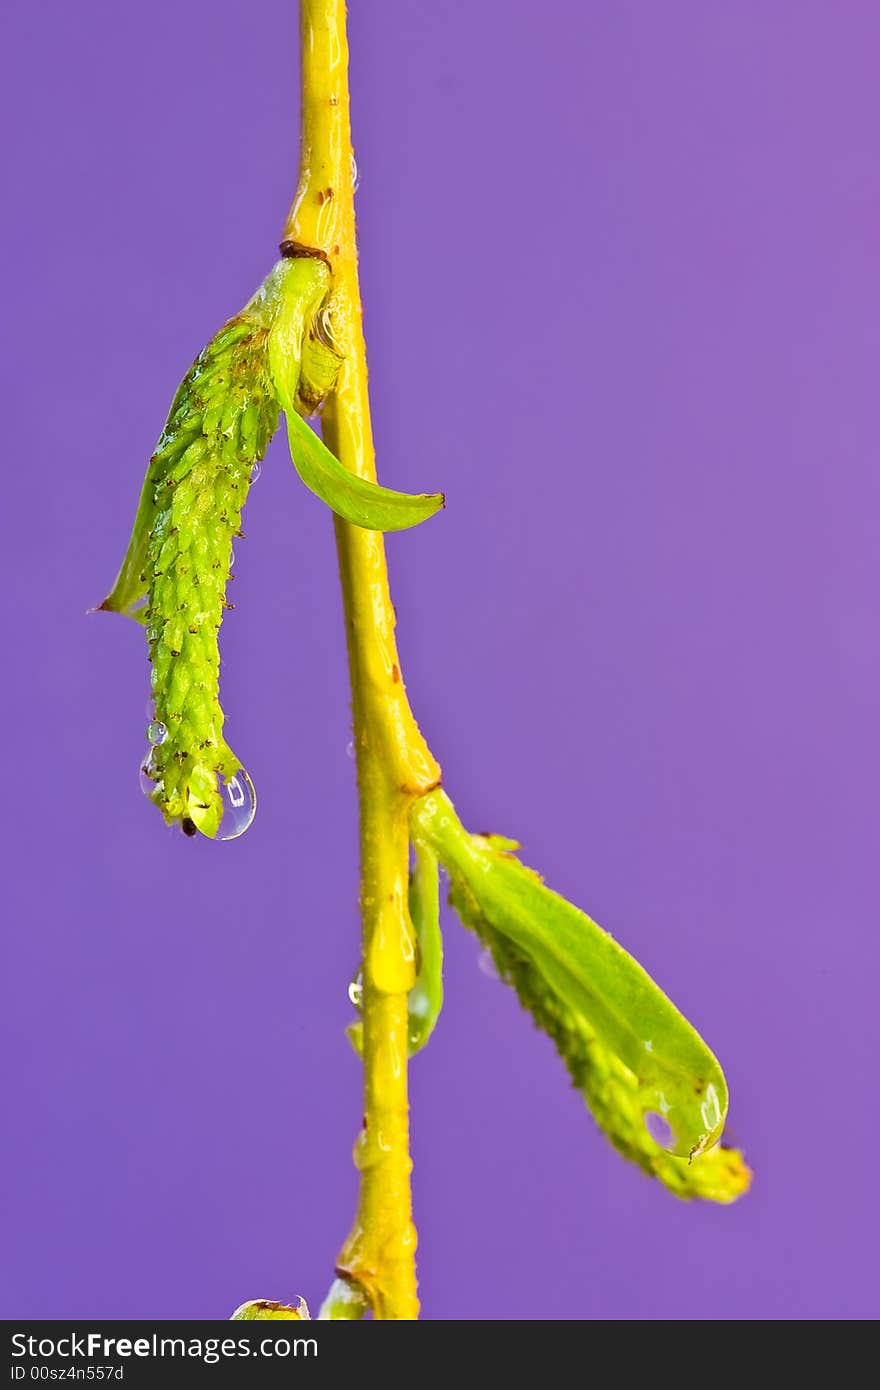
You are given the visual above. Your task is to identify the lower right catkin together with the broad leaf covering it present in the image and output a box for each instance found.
[412,788,751,1202]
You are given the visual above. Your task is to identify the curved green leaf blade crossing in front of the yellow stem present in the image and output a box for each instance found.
[286,410,443,531]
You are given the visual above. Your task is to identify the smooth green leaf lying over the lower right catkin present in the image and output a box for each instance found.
[413,791,727,1158]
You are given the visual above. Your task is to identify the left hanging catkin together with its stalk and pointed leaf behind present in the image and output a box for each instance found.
[101,260,339,838]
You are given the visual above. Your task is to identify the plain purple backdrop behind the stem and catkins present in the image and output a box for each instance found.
[0,0,880,1319]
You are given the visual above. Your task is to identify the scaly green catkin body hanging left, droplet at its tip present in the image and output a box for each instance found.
[143,312,278,837]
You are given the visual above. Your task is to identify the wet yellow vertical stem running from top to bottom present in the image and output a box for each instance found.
[282,0,439,1319]
